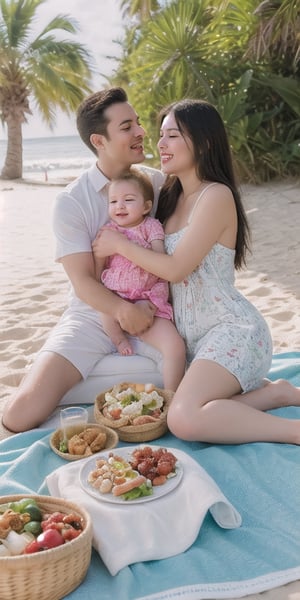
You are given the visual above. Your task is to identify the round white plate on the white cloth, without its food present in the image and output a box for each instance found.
[79,444,183,504]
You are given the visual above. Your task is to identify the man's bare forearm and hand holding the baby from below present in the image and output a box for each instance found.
[60,252,154,335]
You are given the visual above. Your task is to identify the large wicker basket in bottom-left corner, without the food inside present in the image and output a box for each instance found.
[0,494,92,600]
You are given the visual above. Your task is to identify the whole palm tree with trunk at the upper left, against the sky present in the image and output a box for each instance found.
[0,0,92,179]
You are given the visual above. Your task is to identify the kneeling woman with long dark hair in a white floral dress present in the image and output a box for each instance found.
[94,100,300,444]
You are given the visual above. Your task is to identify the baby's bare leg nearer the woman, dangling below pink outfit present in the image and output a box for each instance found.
[139,317,186,392]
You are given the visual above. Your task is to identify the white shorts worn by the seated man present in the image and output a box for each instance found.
[40,308,162,379]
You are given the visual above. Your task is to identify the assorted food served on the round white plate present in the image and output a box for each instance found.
[87,446,177,500]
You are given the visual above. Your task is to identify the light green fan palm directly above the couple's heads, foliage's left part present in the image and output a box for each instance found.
[110,0,229,155]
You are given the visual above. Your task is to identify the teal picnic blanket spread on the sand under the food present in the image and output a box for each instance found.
[0,352,300,600]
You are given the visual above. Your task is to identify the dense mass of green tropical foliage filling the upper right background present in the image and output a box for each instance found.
[110,0,300,182]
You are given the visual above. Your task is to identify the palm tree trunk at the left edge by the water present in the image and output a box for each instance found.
[1,117,23,179]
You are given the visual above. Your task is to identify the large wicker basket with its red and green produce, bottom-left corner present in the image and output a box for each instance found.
[0,495,92,600]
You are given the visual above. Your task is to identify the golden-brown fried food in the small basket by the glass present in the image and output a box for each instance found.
[59,427,107,456]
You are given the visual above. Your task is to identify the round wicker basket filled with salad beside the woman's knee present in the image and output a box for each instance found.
[94,382,174,442]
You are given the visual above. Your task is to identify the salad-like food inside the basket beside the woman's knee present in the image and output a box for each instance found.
[102,383,164,425]
